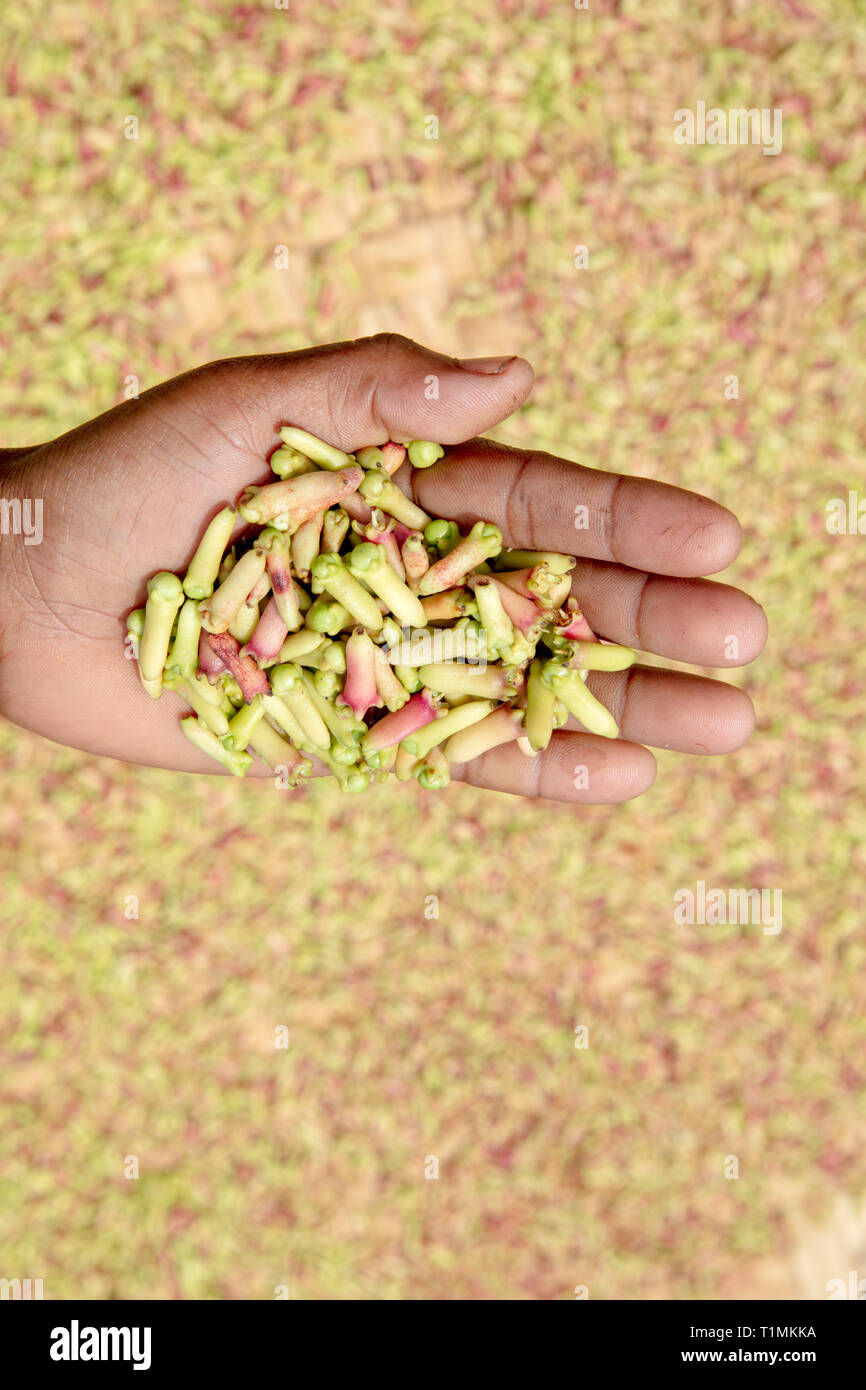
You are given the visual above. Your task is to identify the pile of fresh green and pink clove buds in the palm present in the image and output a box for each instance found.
[126,427,637,792]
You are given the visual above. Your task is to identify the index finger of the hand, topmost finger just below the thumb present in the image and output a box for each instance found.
[399,439,742,578]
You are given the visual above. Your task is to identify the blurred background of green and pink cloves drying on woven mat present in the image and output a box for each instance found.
[0,0,866,1298]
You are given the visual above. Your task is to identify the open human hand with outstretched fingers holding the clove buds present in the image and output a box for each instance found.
[0,334,766,802]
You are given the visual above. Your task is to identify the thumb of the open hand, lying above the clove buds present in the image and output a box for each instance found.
[204,334,534,453]
